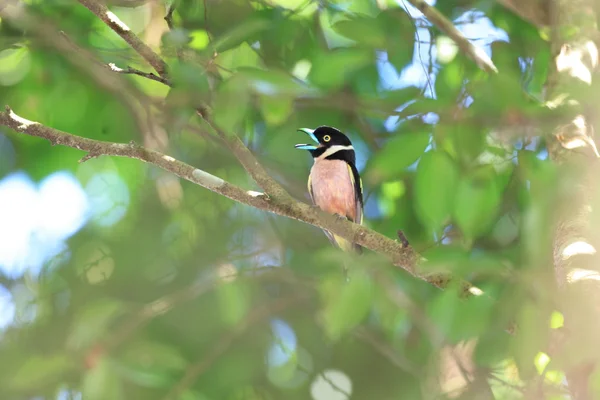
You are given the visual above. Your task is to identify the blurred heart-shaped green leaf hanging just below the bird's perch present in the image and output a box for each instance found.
[319,271,373,340]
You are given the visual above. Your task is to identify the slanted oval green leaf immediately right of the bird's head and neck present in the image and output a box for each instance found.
[369,131,430,182]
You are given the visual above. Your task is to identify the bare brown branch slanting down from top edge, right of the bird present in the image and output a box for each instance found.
[408,0,498,72]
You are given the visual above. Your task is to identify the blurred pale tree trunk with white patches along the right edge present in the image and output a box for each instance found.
[544,0,600,400]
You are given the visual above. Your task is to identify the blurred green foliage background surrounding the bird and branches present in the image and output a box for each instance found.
[0,0,590,399]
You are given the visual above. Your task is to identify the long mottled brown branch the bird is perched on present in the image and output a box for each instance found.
[0,107,422,278]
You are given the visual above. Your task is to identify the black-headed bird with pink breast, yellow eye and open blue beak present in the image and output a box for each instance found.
[295,126,363,253]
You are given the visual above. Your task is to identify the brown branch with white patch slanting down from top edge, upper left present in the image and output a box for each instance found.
[79,0,168,78]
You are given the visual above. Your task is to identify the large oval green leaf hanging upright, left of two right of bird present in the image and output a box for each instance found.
[415,151,459,232]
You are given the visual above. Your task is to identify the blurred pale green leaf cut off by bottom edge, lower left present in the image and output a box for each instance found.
[82,357,123,400]
